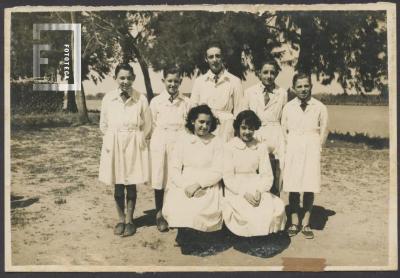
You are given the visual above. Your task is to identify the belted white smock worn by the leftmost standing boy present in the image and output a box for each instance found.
[99,89,151,185]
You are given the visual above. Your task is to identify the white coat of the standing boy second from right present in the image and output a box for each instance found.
[245,82,288,163]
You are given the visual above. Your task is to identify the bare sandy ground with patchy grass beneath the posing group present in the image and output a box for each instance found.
[11,126,389,266]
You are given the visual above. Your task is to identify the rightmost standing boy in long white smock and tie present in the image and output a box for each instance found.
[282,73,328,239]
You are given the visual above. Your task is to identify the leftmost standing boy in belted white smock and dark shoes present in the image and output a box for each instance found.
[99,64,151,236]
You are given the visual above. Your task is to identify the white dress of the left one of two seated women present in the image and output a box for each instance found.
[162,134,223,232]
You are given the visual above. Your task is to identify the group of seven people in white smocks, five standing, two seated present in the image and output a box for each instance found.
[99,44,327,244]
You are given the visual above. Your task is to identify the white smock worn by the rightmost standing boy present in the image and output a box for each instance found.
[282,98,328,193]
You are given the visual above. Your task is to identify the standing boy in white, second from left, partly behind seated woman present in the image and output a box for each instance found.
[150,67,189,232]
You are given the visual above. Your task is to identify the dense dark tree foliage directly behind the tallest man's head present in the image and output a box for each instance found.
[146,11,278,78]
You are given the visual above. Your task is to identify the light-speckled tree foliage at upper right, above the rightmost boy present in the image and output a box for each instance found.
[276,11,387,93]
